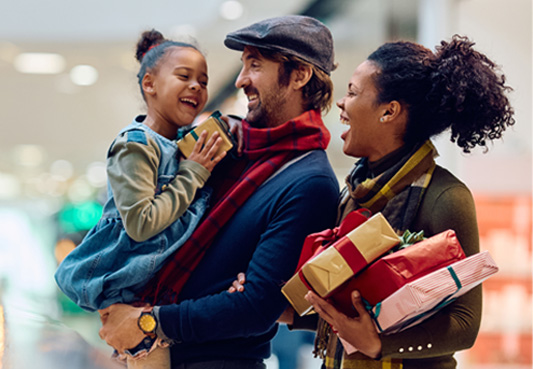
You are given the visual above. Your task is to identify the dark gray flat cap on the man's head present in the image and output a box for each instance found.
[224,15,335,75]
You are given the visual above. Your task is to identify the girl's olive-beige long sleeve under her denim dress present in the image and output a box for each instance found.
[107,135,211,242]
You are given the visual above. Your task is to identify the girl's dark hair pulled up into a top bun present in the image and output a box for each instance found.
[135,29,201,98]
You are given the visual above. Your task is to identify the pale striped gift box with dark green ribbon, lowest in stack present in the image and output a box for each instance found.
[341,251,498,354]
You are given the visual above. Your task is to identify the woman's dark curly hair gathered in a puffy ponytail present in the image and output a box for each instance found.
[368,35,515,153]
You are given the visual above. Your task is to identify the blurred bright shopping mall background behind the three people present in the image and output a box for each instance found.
[0,0,532,369]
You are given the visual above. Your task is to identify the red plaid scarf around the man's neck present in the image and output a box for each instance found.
[140,110,331,305]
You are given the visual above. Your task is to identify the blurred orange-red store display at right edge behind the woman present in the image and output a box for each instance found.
[462,195,533,369]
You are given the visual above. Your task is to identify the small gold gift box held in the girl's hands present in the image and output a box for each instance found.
[178,110,233,158]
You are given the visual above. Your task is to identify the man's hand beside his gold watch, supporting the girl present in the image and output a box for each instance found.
[99,304,146,355]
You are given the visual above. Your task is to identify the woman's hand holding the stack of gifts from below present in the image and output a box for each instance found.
[305,291,381,359]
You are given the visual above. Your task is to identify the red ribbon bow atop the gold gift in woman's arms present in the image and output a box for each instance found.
[296,208,372,271]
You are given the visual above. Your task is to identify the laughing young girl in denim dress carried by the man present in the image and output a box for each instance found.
[55,30,225,368]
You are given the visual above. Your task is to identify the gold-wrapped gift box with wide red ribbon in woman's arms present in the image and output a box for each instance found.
[281,213,401,316]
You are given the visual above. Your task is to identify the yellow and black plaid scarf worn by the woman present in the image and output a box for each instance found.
[315,140,437,369]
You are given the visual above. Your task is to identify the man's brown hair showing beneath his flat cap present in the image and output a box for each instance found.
[247,48,333,112]
